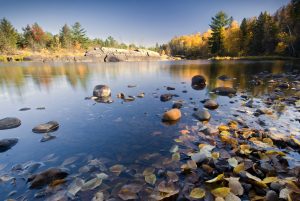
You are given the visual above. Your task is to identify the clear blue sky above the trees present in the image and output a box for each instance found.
[0,0,289,46]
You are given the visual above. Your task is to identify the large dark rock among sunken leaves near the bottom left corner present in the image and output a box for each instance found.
[28,168,68,189]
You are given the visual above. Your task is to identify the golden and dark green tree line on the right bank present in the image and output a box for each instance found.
[168,0,300,58]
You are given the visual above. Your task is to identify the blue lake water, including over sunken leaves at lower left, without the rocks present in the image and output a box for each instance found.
[0,60,300,200]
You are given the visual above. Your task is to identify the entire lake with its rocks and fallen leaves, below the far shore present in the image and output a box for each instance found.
[0,60,300,201]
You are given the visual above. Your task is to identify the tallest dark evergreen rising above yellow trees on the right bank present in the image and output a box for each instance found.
[209,11,232,55]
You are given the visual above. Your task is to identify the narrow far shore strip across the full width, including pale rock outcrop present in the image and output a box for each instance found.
[0,50,300,62]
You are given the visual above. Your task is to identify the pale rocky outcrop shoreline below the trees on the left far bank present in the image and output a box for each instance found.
[3,47,170,62]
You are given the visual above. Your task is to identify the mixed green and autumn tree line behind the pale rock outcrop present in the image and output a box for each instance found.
[0,18,144,54]
